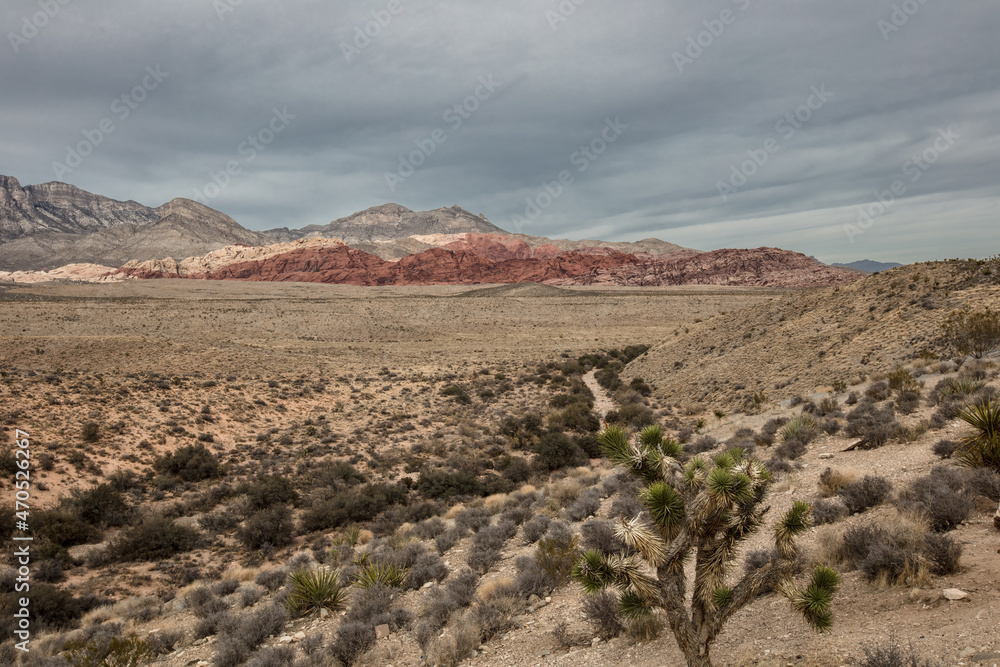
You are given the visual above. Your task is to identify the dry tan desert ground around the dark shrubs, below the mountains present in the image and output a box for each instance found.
[0,267,1000,667]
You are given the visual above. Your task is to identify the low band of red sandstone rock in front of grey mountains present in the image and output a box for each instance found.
[111,243,860,287]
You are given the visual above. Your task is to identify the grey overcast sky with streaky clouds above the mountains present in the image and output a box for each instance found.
[0,0,1000,262]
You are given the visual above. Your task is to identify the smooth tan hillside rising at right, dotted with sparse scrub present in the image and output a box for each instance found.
[625,260,1000,409]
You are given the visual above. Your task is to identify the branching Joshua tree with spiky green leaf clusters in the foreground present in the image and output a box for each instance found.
[573,425,840,667]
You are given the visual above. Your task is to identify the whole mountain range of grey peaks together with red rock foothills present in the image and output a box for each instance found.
[0,176,859,287]
